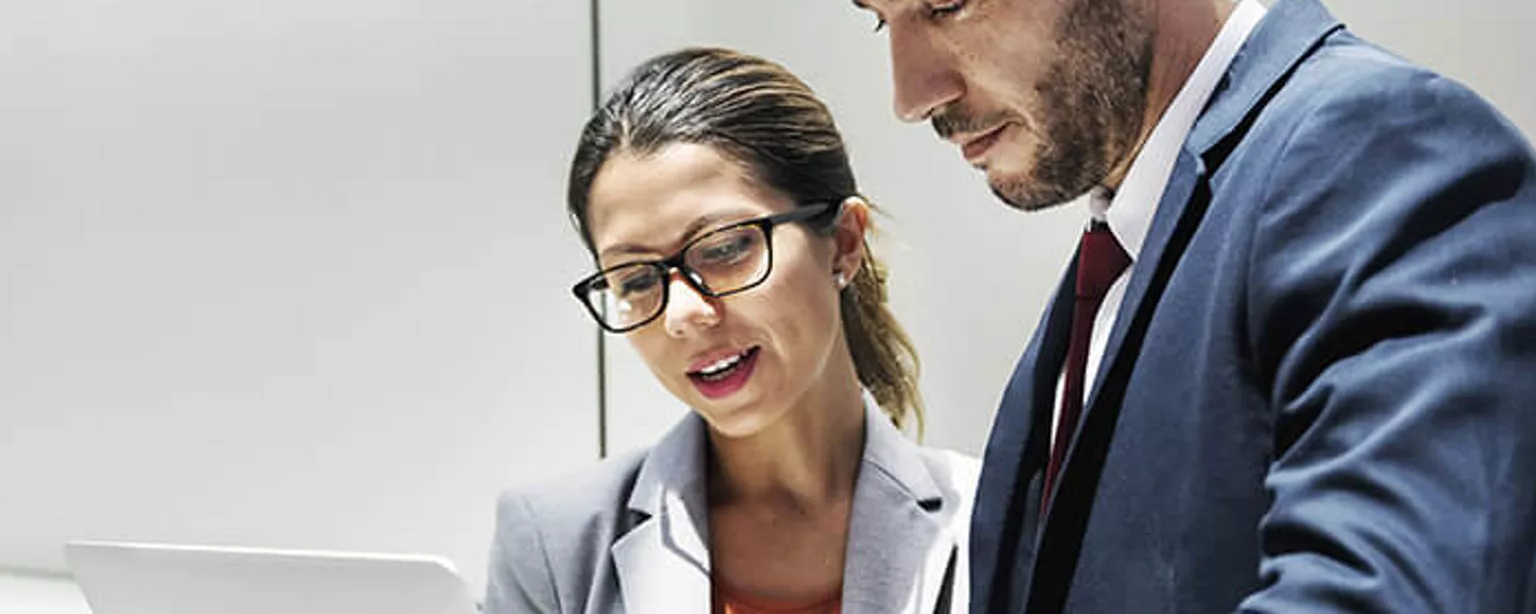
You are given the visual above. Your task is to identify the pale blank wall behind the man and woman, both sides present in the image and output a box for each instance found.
[0,0,1536,614]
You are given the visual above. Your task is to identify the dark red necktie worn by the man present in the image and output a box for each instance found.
[1040,220,1130,514]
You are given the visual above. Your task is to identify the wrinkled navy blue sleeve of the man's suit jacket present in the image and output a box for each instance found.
[1240,69,1536,614]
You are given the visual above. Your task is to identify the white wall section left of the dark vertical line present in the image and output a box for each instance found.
[0,0,598,598]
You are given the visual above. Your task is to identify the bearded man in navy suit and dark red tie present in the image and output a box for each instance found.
[856,0,1536,614]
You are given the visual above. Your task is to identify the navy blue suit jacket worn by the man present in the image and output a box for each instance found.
[971,0,1536,614]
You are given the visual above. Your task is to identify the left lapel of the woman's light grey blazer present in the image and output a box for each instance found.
[610,414,711,614]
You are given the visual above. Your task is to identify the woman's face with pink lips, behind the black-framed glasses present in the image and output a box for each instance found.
[587,144,865,437]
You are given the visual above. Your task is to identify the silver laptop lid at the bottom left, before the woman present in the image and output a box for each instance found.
[65,542,478,614]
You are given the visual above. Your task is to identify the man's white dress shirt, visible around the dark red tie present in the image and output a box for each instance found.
[1051,0,1266,444]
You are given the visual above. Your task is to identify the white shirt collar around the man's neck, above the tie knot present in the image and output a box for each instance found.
[1087,0,1266,261]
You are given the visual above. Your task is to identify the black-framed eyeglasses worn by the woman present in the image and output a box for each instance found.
[571,203,842,333]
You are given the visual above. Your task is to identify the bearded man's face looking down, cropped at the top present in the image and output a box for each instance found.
[854,0,1152,210]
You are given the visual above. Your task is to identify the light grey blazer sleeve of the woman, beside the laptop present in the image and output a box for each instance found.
[484,493,561,614]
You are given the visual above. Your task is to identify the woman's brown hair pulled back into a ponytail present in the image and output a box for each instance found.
[567,48,923,433]
